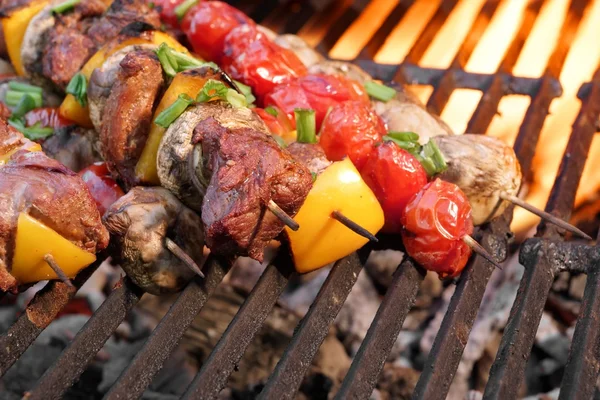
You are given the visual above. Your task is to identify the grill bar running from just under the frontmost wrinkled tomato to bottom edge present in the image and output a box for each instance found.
[336,260,425,400]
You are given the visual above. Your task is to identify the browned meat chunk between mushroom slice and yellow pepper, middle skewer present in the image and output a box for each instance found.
[100,50,164,187]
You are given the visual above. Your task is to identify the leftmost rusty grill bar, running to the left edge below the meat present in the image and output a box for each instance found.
[0,254,104,377]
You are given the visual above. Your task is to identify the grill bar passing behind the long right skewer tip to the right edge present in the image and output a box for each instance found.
[484,67,600,399]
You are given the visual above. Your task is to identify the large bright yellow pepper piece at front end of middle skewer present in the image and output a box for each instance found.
[286,158,384,273]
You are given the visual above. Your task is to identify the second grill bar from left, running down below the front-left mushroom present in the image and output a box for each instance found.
[28,278,143,400]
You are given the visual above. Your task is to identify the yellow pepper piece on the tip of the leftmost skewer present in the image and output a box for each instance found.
[10,213,96,283]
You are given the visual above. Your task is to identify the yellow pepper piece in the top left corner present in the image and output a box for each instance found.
[2,0,50,76]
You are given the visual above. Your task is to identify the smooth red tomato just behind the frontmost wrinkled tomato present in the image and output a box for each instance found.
[360,142,427,233]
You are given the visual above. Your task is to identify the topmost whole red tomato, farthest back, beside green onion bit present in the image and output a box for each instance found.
[179,0,255,64]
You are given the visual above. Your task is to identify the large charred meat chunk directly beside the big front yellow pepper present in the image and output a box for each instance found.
[192,117,312,261]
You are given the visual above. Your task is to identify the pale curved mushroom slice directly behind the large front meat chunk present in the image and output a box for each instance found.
[157,99,269,212]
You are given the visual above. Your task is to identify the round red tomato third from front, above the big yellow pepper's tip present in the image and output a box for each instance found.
[320,101,387,171]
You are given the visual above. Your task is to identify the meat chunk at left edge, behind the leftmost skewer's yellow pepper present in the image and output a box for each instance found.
[0,121,109,291]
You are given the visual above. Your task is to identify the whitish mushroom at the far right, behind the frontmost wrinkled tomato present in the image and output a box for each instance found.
[433,134,522,225]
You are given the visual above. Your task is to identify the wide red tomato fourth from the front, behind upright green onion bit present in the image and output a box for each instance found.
[264,75,369,129]
